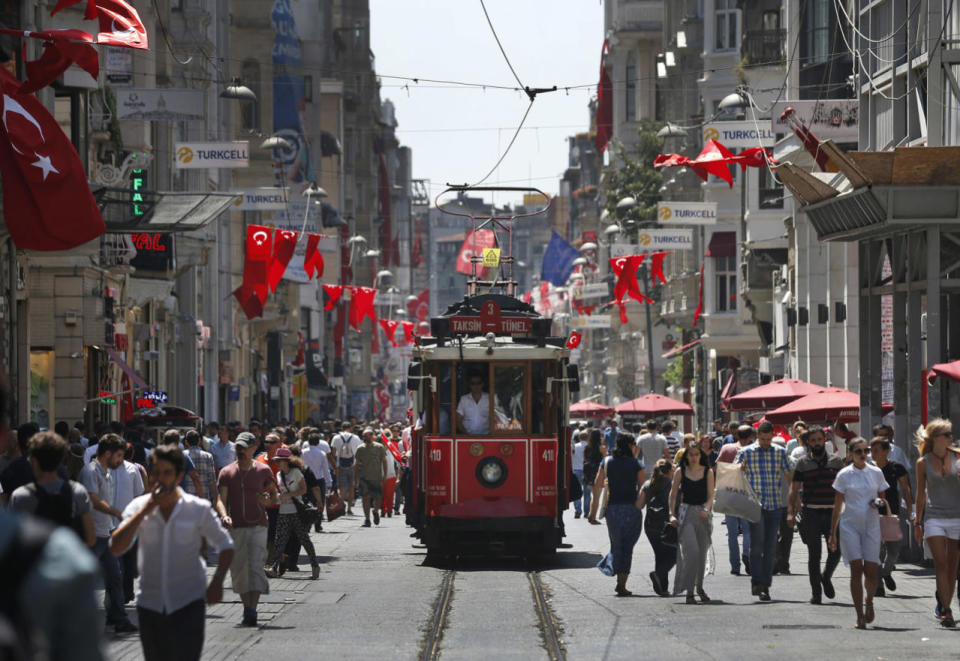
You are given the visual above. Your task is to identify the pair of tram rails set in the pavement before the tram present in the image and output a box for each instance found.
[420,569,567,661]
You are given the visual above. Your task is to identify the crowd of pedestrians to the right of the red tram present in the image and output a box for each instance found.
[573,419,960,628]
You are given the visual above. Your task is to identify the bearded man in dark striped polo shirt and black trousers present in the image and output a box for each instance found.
[787,425,843,604]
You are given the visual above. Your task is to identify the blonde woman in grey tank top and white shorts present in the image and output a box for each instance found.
[914,418,960,627]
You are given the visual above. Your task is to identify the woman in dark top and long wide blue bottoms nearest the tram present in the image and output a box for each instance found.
[594,434,647,597]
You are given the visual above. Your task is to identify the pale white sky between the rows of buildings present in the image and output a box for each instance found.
[370,0,603,203]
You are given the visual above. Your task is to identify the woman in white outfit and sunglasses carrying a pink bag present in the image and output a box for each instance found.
[830,438,890,629]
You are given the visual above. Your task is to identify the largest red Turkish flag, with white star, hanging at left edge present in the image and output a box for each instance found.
[0,70,107,250]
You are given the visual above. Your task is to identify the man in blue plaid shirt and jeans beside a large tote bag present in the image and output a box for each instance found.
[734,422,792,601]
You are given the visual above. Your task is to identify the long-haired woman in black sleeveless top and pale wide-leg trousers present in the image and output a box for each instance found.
[669,437,713,604]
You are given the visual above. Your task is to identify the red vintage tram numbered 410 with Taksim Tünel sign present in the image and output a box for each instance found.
[408,188,578,557]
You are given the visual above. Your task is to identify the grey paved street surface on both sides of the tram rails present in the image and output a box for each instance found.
[108,502,960,661]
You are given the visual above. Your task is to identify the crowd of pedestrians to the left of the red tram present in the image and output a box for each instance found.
[0,393,411,661]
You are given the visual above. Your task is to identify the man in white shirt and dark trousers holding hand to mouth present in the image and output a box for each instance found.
[110,445,233,661]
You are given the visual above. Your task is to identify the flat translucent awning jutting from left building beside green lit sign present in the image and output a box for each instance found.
[93,186,241,233]
